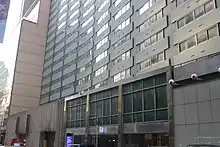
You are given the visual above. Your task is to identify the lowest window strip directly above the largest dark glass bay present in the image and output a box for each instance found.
[140,52,164,70]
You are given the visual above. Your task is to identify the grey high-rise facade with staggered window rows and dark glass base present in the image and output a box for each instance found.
[40,0,220,146]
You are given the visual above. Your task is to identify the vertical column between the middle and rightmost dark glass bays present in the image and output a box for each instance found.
[118,84,124,147]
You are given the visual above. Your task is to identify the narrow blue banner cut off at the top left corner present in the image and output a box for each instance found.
[0,0,10,42]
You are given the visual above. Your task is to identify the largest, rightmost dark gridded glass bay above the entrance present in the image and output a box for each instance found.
[122,74,168,123]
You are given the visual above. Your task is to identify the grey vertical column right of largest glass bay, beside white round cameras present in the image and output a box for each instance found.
[167,60,174,147]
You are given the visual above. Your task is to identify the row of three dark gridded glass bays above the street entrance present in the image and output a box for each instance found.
[67,73,168,128]
